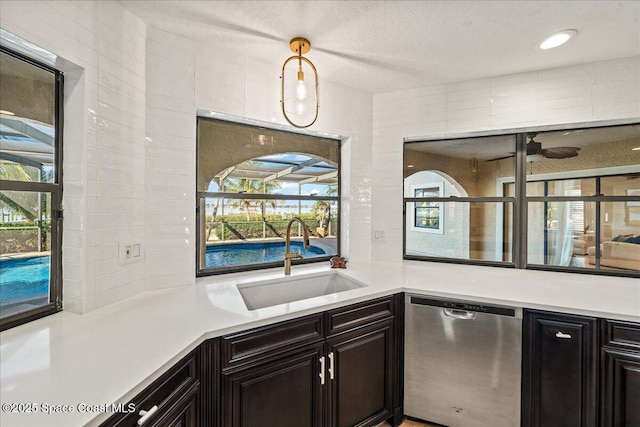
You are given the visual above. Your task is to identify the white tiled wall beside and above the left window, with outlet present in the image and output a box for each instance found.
[0,1,146,312]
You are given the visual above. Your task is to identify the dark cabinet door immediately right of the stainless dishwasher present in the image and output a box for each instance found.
[522,311,598,427]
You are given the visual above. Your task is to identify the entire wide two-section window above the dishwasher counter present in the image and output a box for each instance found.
[404,124,640,277]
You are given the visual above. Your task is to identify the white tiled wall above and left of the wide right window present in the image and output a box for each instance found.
[372,57,640,261]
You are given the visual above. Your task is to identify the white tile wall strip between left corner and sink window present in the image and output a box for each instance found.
[143,28,196,289]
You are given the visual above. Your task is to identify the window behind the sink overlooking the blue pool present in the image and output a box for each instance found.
[196,118,340,275]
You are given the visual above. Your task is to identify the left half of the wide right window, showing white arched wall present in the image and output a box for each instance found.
[404,136,515,265]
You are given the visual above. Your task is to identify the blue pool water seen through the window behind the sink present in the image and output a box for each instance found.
[207,242,327,267]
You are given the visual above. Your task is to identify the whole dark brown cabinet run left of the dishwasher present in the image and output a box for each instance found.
[102,294,404,427]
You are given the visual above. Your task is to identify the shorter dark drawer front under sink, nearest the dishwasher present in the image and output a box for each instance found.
[327,295,393,335]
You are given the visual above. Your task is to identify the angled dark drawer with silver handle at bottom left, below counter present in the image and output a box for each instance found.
[101,352,199,427]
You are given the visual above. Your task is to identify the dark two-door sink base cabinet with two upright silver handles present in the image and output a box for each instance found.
[221,296,398,427]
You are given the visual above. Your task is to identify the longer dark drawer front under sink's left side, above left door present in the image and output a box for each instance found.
[221,313,324,370]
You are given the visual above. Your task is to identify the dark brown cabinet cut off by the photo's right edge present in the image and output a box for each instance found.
[601,320,640,427]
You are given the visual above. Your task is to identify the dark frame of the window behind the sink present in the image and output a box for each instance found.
[195,115,342,277]
